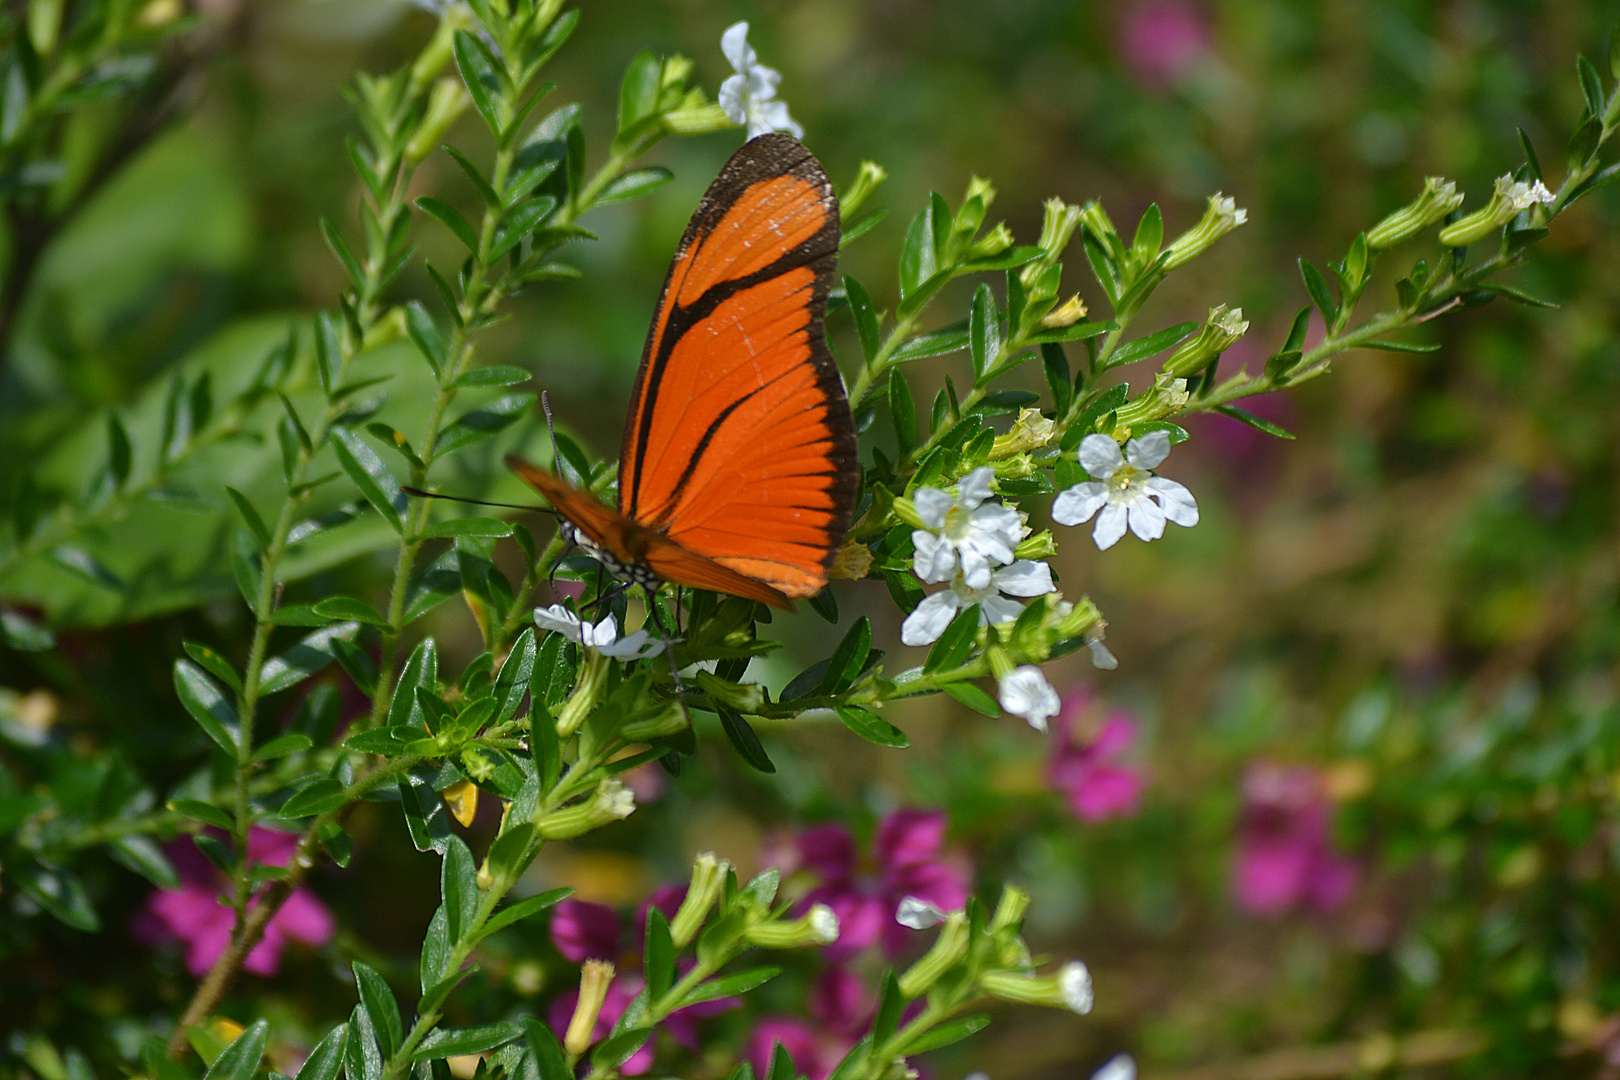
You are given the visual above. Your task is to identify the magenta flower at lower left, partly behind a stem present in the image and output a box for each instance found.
[133,827,335,976]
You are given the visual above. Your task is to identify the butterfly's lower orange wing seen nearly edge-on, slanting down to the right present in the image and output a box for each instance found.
[507,453,792,609]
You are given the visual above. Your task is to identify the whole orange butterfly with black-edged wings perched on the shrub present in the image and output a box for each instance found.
[507,134,860,609]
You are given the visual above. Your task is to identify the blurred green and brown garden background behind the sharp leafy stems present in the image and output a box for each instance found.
[0,0,1620,1080]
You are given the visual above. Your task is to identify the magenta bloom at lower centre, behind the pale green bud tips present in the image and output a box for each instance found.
[761,810,972,962]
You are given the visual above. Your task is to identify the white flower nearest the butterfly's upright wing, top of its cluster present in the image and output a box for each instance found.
[912,466,1029,589]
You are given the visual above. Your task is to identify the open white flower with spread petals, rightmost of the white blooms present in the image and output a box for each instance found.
[1051,431,1199,551]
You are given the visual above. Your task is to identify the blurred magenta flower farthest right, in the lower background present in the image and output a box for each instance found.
[1233,761,1356,915]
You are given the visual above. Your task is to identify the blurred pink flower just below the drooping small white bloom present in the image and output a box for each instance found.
[1047,688,1147,821]
